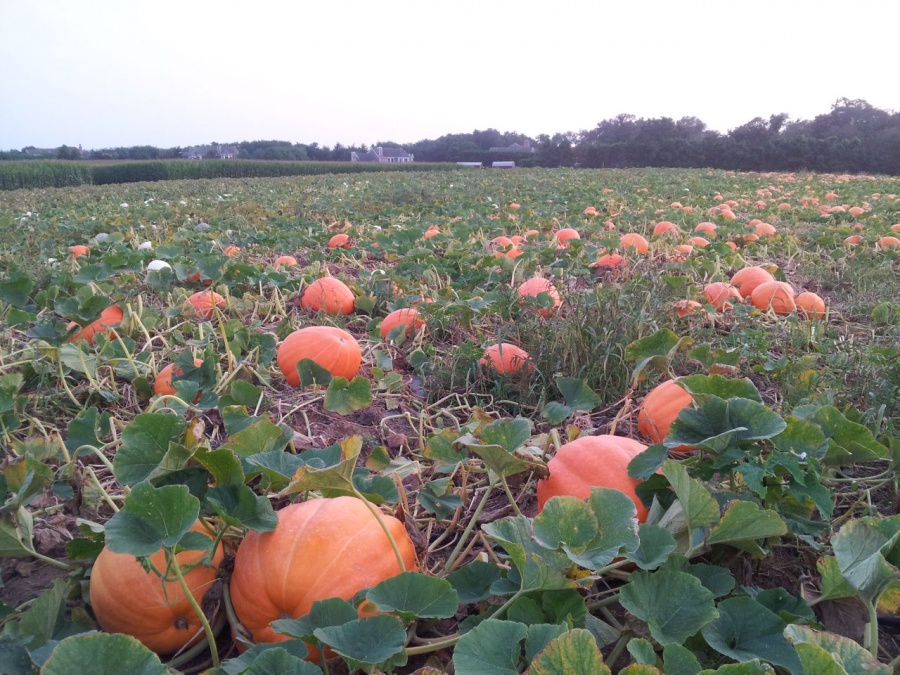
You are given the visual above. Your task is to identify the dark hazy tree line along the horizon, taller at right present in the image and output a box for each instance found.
[0,98,900,175]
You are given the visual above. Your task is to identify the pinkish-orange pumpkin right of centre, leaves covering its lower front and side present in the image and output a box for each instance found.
[537,435,647,523]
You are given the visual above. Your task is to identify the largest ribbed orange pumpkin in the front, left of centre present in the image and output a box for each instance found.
[230,497,416,642]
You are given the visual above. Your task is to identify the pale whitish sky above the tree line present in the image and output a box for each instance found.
[0,0,900,150]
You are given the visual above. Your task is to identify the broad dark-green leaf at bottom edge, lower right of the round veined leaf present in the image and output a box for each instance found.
[702,596,803,674]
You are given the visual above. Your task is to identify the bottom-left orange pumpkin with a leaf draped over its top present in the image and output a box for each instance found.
[90,523,223,654]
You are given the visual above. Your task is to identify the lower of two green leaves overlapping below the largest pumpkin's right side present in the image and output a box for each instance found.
[313,615,406,669]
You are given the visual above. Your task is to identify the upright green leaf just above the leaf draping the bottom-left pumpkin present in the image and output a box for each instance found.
[113,413,187,485]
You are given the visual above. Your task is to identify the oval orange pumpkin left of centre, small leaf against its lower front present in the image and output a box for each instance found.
[276,326,362,387]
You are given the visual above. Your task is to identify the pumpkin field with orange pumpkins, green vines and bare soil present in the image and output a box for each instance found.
[0,169,900,675]
